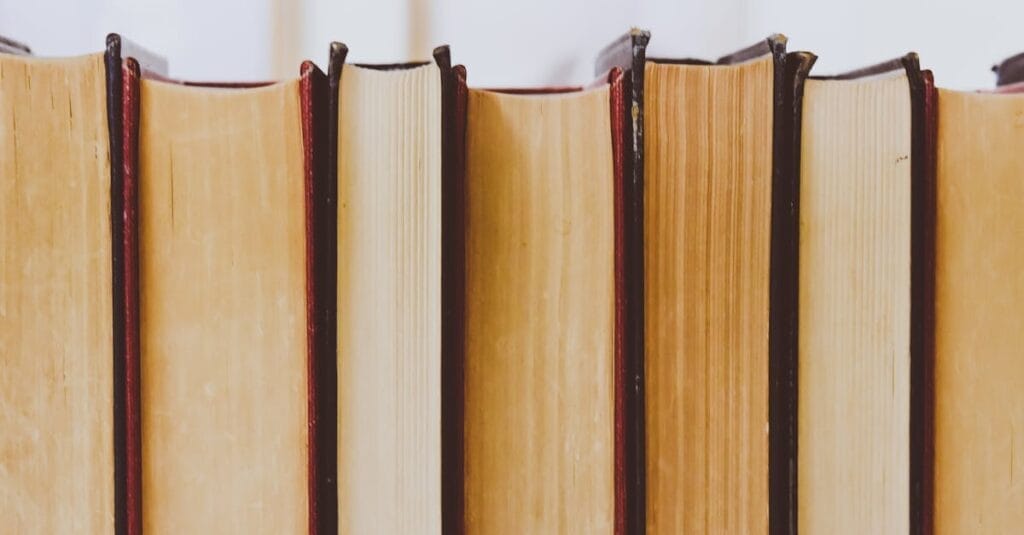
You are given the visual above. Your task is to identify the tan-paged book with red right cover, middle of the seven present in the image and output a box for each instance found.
[460,69,625,533]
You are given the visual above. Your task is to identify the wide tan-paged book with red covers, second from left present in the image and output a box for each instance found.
[128,54,336,533]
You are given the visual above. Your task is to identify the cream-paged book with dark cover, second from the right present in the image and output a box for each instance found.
[797,54,934,533]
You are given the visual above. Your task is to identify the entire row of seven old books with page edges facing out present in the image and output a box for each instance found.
[0,30,1024,535]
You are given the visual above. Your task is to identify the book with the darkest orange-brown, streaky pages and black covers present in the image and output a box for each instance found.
[602,36,809,533]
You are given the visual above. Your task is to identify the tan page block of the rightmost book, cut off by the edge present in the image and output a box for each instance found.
[927,78,1024,533]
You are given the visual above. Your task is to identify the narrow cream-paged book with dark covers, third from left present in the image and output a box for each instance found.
[329,43,462,534]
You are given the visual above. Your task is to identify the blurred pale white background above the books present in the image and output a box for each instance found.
[0,0,1024,89]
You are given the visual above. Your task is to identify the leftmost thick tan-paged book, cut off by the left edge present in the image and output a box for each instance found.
[0,35,164,533]
